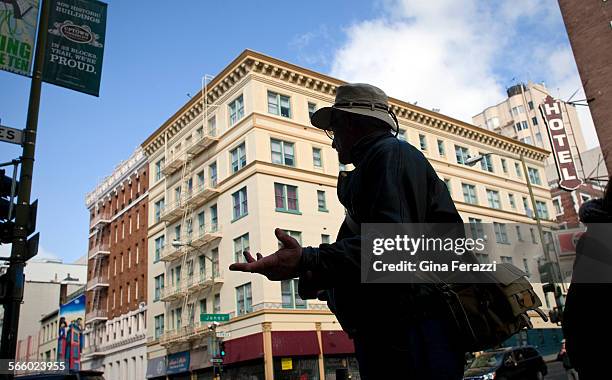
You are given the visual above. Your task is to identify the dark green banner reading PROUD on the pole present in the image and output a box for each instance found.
[42,0,106,96]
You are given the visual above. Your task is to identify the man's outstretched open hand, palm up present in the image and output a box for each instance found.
[229,228,302,281]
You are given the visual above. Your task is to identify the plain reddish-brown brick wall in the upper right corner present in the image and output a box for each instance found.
[559,0,612,173]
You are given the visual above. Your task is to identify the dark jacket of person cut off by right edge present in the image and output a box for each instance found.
[563,199,612,372]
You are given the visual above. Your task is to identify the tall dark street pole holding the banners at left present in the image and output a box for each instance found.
[0,0,51,360]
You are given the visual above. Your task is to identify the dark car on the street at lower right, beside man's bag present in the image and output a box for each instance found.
[463,346,548,380]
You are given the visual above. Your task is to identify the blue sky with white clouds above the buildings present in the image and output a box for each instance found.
[0,0,596,262]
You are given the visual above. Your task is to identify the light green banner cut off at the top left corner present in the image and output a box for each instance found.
[0,0,39,76]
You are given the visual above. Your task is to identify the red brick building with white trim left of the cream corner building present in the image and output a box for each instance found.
[82,149,149,379]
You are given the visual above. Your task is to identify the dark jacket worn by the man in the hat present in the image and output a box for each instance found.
[299,132,462,335]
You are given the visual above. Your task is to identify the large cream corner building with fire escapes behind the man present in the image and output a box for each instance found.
[142,50,560,379]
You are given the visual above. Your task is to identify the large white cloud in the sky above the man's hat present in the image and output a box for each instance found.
[328,0,596,146]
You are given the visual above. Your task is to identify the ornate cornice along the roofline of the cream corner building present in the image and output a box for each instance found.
[143,50,549,161]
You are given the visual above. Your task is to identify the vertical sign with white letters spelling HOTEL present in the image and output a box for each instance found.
[540,95,582,191]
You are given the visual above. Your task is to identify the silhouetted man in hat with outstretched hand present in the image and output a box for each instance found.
[230,84,464,380]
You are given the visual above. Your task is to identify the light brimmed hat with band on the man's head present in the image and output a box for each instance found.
[310,83,399,131]
